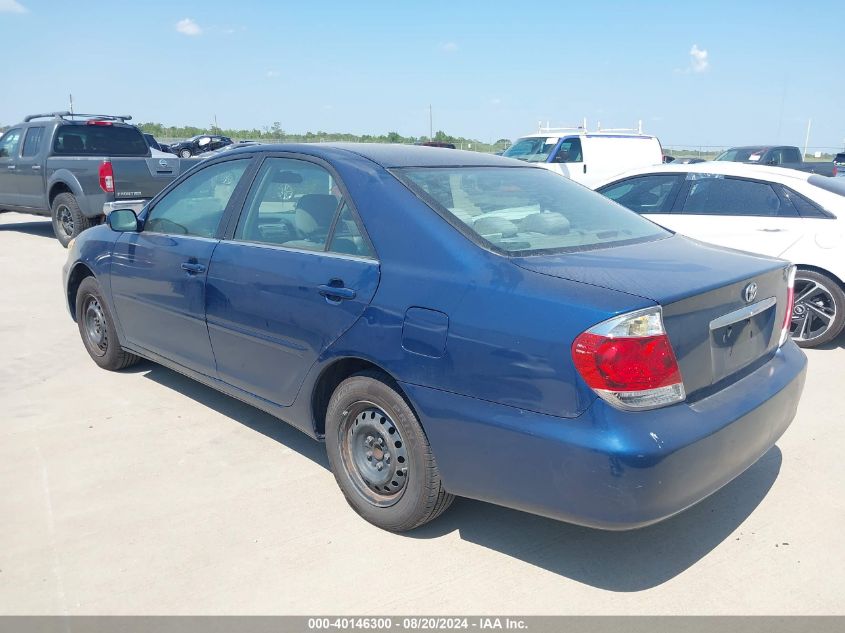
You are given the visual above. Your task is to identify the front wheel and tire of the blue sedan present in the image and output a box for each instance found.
[76,277,140,371]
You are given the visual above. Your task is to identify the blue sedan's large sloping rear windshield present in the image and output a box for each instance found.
[393,167,670,255]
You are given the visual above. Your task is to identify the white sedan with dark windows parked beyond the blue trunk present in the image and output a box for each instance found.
[595,162,845,347]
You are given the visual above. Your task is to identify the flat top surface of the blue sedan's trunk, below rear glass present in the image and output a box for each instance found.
[514,235,786,305]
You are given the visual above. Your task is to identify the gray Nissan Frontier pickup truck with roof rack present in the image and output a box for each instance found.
[0,112,196,247]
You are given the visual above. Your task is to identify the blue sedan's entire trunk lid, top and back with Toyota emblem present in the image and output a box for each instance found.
[514,235,789,400]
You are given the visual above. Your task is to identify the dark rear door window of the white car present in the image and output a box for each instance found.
[681,174,794,216]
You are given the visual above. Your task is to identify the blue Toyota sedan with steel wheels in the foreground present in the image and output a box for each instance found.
[64,144,806,531]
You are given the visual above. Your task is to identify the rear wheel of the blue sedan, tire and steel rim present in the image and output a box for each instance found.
[326,371,454,532]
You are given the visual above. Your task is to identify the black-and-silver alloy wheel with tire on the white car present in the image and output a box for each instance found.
[790,269,845,348]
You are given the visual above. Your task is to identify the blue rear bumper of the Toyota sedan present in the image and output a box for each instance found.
[402,341,807,530]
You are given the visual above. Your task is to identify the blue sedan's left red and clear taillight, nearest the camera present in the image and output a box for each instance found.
[572,308,686,409]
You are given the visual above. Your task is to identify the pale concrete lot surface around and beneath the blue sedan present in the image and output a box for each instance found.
[0,214,845,615]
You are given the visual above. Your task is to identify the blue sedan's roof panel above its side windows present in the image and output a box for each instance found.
[214,143,529,168]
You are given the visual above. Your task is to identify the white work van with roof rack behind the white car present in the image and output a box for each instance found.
[503,125,663,187]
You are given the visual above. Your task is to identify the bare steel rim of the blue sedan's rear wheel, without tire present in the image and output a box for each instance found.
[338,402,410,508]
